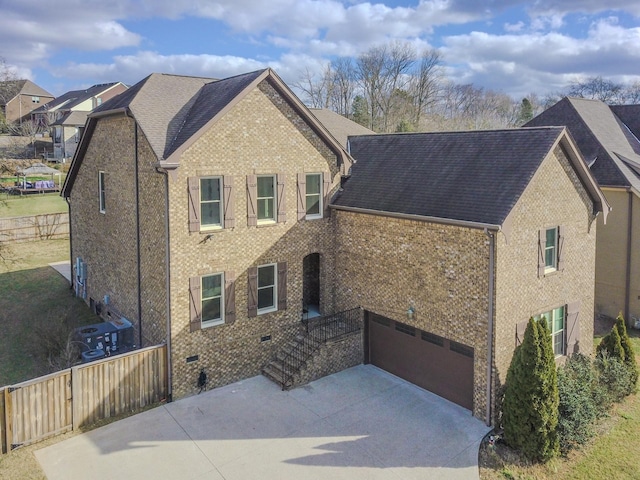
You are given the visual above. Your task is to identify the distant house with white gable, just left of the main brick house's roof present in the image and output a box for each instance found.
[32,82,127,161]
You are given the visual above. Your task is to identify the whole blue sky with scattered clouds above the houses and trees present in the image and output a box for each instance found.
[0,0,640,98]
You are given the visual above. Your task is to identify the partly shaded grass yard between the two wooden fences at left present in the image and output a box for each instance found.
[0,240,98,385]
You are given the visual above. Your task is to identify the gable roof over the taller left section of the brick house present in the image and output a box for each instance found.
[62,68,351,196]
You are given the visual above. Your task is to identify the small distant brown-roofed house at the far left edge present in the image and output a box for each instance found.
[0,80,55,123]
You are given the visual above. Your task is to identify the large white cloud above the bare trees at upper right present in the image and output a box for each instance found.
[443,19,640,95]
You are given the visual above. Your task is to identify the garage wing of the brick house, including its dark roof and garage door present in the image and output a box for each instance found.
[332,128,609,423]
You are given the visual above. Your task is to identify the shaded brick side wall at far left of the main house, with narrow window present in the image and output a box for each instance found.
[70,116,140,338]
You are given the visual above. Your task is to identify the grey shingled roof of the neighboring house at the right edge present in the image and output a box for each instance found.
[525,97,640,191]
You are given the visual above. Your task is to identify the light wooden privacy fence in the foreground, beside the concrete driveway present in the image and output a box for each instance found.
[0,345,167,453]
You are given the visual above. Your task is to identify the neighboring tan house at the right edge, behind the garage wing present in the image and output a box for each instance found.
[527,97,640,325]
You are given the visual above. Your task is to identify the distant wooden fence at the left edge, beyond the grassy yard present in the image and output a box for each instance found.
[0,213,69,243]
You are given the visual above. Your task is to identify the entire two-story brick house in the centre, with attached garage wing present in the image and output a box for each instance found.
[63,69,608,423]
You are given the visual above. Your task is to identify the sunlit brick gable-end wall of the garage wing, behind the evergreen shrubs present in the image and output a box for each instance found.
[493,146,596,422]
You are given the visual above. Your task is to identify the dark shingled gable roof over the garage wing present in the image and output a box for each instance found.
[332,127,608,229]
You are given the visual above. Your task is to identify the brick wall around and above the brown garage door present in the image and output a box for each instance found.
[334,210,489,418]
